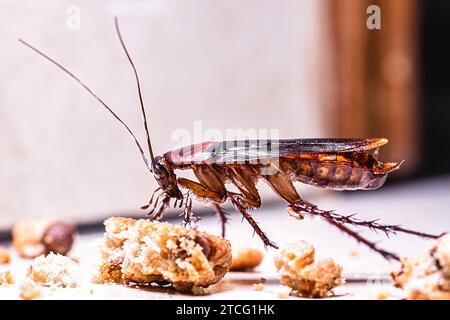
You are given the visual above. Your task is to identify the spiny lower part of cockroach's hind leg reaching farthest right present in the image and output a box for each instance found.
[288,200,439,239]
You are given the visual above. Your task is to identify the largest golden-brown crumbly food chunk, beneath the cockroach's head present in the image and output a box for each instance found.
[93,217,231,292]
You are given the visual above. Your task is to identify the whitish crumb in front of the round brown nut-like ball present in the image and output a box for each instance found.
[27,253,81,288]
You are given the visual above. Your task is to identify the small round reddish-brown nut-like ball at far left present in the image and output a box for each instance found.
[41,221,76,255]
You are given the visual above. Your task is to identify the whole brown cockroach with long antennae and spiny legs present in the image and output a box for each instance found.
[19,17,438,260]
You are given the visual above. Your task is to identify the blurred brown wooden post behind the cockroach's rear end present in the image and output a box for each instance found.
[328,0,419,174]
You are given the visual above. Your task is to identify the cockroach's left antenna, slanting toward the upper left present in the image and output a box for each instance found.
[18,39,154,172]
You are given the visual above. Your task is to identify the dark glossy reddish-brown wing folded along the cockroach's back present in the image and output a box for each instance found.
[164,138,388,166]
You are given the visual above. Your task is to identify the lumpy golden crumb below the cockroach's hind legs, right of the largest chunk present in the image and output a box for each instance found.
[275,241,344,298]
